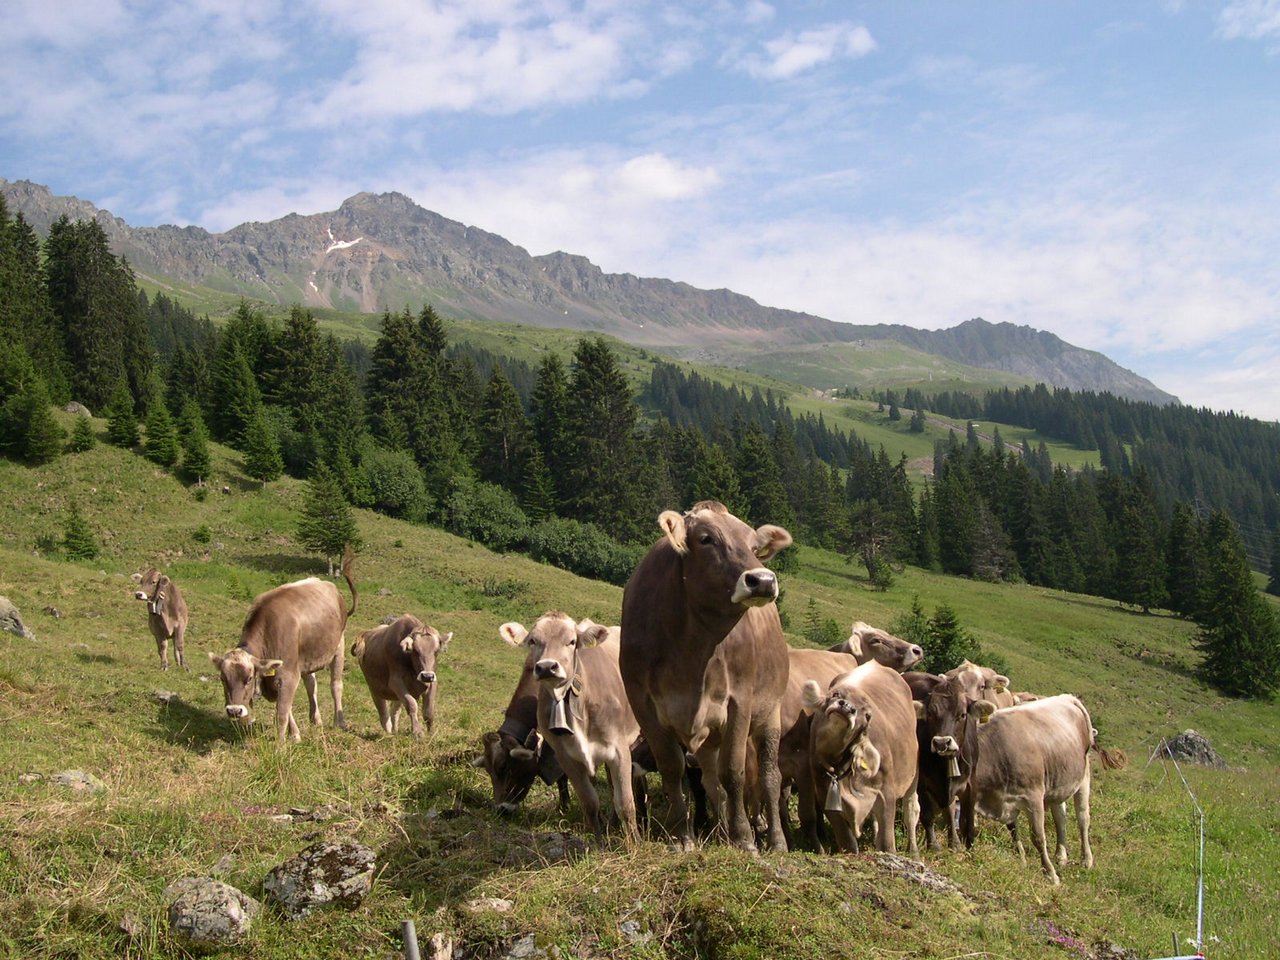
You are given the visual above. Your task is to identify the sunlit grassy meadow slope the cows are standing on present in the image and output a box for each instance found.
[0,421,1280,960]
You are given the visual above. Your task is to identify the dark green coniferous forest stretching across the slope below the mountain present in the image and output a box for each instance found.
[0,200,1280,696]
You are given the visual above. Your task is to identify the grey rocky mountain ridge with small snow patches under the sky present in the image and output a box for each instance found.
[0,179,1175,403]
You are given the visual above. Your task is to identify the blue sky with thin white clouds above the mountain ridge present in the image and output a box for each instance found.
[0,0,1280,420]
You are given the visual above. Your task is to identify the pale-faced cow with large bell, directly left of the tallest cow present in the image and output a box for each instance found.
[498,611,640,840]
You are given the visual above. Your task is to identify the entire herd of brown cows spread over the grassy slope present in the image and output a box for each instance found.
[136,500,1124,883]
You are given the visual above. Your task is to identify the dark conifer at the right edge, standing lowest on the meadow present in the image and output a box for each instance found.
[1196,511,1280,700]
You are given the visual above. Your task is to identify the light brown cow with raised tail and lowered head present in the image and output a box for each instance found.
[209,547,356,740]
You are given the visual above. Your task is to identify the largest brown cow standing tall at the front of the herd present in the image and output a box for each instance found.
[621,500,791,850]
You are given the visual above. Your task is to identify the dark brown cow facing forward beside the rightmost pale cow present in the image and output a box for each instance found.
[902,673,996,850]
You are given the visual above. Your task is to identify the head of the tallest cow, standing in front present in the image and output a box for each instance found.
[658,500,791,609]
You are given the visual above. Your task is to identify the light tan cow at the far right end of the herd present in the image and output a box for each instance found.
[961,694,1125,884]
